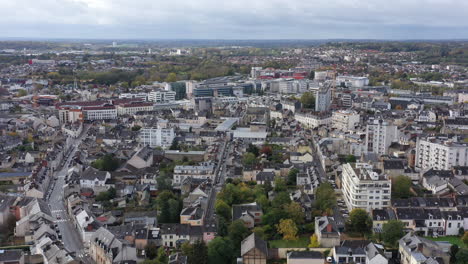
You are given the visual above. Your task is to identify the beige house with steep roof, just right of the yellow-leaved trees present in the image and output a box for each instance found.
[315,216,341,247]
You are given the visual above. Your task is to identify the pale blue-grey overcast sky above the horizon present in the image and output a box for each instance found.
[0,0,468,39]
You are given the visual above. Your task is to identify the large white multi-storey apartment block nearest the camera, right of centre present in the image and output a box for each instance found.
[342,163,392,212]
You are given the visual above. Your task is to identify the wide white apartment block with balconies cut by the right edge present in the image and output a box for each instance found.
[415,137,468,170]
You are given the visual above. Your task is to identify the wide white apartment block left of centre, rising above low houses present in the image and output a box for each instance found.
[139,128,175,148]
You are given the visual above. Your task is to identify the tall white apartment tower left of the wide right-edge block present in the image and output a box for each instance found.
[366,119,398,155]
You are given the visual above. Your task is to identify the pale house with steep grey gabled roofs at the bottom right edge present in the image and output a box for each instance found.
[398,233,451,264]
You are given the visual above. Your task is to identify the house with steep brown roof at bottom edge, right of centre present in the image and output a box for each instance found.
[241,233,268,264]
